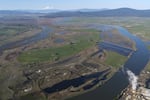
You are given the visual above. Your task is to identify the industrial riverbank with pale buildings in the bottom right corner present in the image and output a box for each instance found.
[118,63,150,100]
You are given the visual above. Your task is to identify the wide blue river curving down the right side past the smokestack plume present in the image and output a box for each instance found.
[69,26,149,100]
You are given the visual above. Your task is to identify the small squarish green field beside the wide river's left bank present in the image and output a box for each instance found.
[104,51,127,68]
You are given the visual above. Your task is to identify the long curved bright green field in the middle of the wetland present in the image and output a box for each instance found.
[18,30,100,63]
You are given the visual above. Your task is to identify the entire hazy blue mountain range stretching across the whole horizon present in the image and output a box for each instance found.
[0,8,150,18]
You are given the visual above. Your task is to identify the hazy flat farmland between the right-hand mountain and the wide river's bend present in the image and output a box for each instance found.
[64,17,150,41]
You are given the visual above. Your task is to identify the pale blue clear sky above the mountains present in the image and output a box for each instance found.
[0,0,150,10]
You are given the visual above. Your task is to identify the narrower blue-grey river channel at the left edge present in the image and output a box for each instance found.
[0,26,52,54]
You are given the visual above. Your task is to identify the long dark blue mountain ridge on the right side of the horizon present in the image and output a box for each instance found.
[44,8,150,17]
